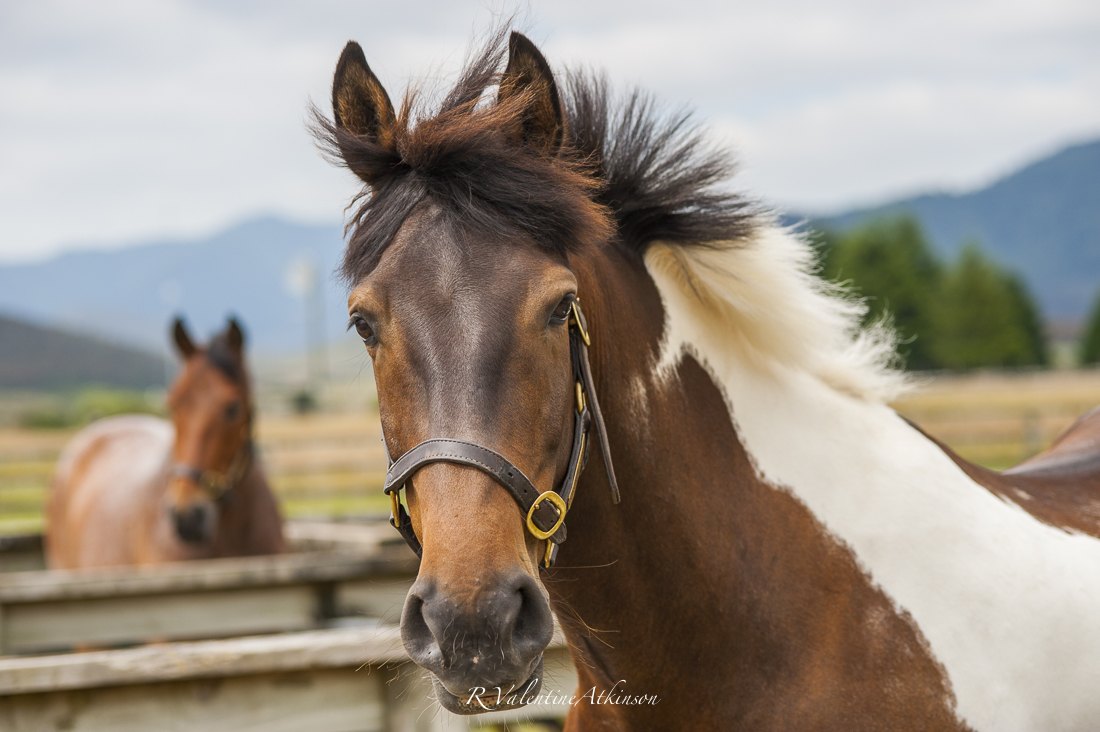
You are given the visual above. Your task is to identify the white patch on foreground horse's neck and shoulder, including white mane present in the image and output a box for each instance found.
[646,220,1100,732]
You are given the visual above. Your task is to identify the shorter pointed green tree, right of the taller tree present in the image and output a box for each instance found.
[935,243,1046,369]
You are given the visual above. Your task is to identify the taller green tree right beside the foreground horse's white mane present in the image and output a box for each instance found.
[821,217,942,369]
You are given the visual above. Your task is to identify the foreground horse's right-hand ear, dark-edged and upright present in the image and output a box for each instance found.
[497,31,565,155]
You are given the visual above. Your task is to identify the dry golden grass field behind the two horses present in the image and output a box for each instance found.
[0,371,1100,534]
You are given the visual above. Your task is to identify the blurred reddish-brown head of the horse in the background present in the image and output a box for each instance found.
[168,318,252,544]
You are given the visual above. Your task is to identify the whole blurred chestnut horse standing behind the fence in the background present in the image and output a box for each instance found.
[46,319,283,568]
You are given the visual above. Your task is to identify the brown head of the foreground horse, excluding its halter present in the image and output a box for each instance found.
[320,34,609,713]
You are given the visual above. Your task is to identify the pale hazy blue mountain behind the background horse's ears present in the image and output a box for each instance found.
[0,218,347,353]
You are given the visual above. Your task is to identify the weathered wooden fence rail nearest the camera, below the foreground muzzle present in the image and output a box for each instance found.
[0,625,576,732]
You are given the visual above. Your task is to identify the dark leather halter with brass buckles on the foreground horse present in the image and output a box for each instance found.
[382,299,619,569]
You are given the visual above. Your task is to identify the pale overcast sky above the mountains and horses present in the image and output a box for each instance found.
[0,0,1100,262]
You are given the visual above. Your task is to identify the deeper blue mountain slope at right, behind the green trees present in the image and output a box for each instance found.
[806,140,1100,320]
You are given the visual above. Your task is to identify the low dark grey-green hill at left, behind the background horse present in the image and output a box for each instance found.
[0,315,165,389]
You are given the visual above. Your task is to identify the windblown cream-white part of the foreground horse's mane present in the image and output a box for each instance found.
[646,227,909,402]
